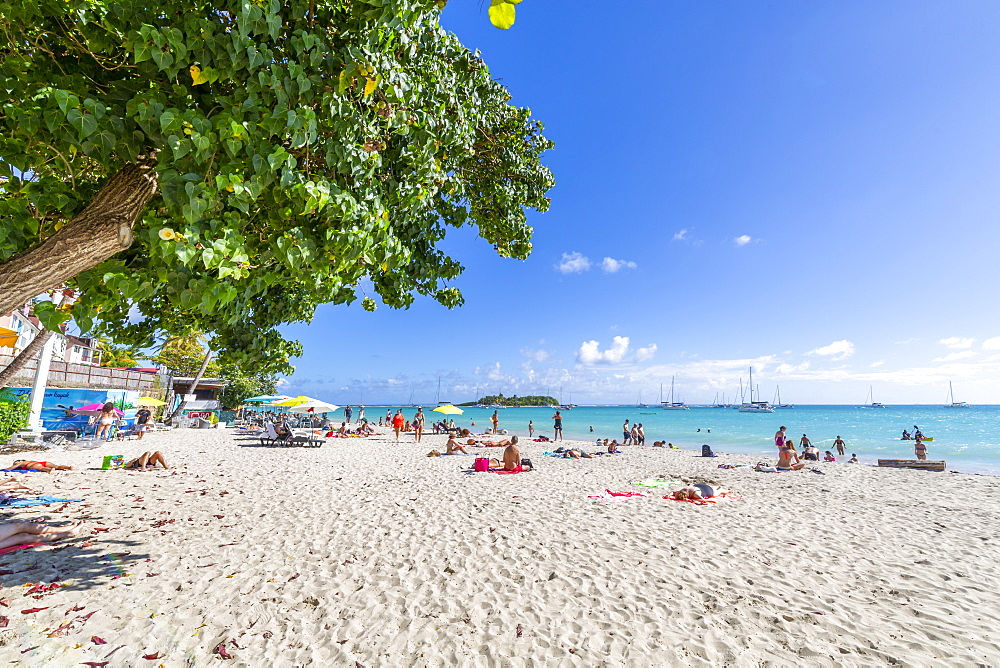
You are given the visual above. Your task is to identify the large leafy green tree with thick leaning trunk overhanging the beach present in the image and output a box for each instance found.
[0,0,553,371]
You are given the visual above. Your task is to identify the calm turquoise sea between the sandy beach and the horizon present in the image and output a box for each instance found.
[352,405,1000,475]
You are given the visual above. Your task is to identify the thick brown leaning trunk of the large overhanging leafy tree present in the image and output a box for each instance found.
[0,160,158,313]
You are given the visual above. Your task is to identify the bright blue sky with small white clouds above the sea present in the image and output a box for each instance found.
[283,0,1000,404]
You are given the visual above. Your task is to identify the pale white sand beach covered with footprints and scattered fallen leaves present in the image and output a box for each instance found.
[0,430,1000,668]
